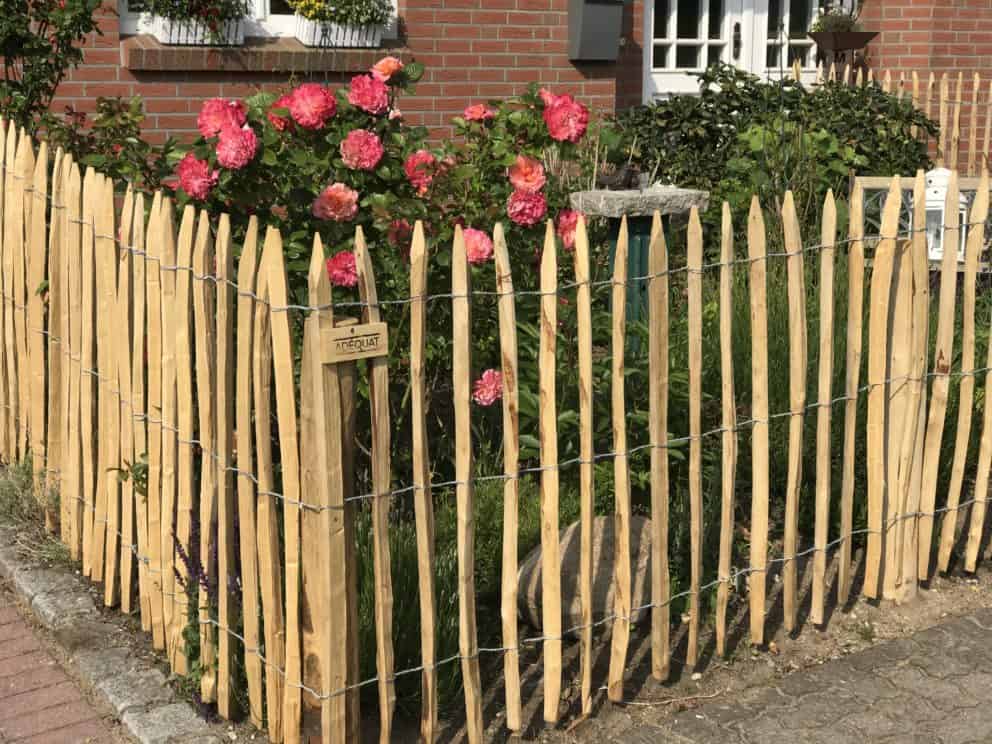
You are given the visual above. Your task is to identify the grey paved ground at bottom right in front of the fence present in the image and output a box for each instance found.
[589,608,992,744]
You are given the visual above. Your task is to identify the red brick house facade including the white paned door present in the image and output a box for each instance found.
[57,0,992,145]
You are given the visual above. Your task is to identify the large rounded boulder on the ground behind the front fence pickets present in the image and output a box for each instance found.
[517,517,651,631]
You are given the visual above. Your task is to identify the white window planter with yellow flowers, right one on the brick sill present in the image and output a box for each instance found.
[290,0,393,48]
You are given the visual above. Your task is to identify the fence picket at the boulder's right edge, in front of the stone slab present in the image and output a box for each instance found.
[644,211,672,680]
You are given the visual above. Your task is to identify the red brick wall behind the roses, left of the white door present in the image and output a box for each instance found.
[56,0,641,141]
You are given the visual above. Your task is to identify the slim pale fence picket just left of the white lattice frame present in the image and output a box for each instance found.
[810,191,837,625]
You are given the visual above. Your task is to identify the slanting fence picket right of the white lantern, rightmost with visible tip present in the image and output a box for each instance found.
[937,171,989,571]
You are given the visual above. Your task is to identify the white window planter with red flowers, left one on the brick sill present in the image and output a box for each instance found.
[148,0,249,46]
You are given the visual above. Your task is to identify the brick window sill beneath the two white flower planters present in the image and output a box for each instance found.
[121,34,407,73]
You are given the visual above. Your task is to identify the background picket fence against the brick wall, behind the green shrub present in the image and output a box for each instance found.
[808,63,992,176]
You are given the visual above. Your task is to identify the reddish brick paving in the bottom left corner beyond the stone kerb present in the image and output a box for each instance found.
[0,590,120,744]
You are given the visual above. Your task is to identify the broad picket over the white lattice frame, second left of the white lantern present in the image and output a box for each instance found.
[864,176,902,598]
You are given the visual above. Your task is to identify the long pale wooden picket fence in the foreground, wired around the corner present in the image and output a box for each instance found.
[0,115,992,742]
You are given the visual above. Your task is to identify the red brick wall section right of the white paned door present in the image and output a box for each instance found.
[861,0,992,168]
